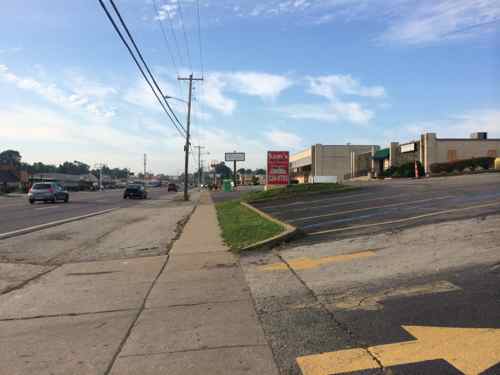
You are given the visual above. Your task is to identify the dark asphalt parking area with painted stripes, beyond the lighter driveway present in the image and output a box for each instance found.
[252,174,500,242]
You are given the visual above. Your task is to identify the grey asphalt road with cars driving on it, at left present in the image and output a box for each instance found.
[0,188,179,235]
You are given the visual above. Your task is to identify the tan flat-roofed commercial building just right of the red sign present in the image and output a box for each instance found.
[290,144,380,183]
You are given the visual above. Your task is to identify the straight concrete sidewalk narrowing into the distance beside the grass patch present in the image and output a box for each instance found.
[111,194,278,375]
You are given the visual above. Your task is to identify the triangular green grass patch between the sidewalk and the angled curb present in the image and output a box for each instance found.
[215,200,285,251]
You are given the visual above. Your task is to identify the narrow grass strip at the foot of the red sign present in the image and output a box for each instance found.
[242,183,358,203]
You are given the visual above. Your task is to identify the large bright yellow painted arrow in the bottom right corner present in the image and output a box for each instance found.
[297,326,500,375]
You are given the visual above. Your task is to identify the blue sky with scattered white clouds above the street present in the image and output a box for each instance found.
[0,0,500,174]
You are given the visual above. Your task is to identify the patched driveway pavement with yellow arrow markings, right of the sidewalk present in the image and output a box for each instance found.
[241,215,500,375]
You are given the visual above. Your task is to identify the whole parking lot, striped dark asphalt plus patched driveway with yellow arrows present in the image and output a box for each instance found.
[241,174,500,375]
